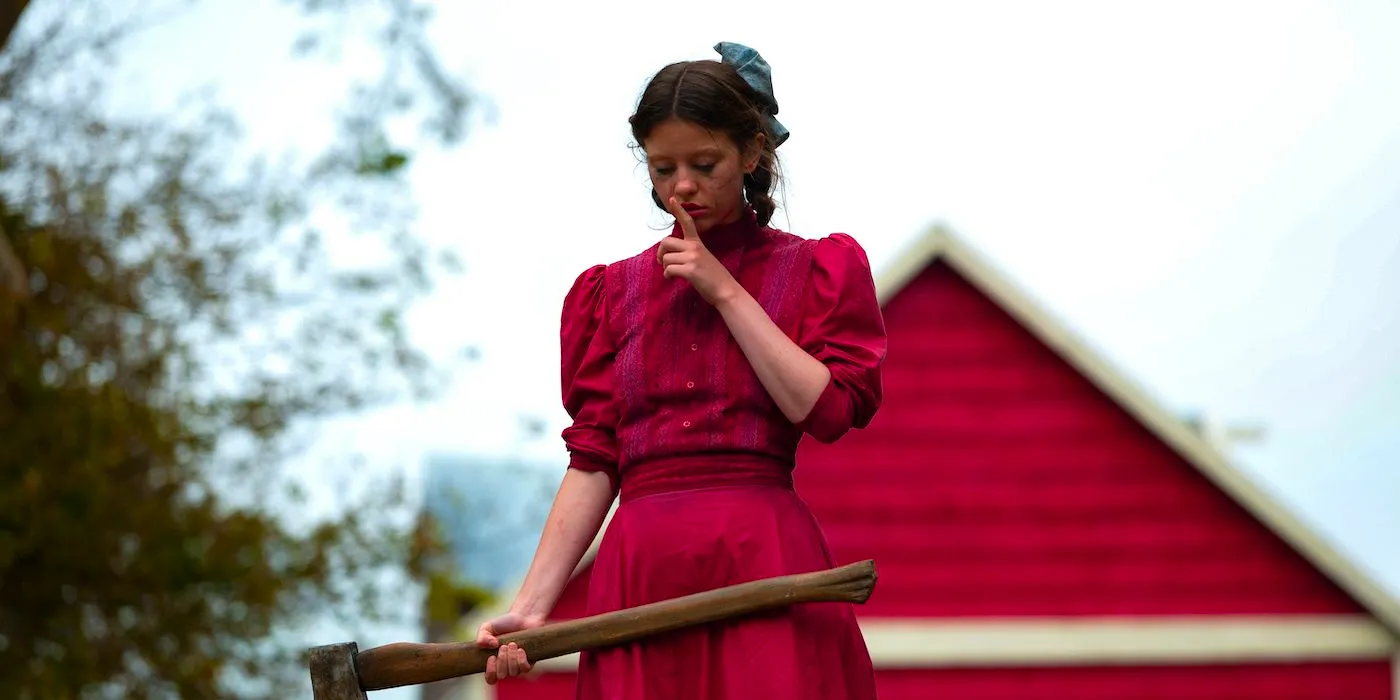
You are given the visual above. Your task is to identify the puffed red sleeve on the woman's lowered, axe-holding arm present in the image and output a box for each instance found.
[559,265,617,489]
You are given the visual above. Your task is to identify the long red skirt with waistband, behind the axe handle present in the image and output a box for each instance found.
[577,459,875,700]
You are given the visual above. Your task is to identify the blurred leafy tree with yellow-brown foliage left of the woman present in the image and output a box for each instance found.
[0,0,475,700]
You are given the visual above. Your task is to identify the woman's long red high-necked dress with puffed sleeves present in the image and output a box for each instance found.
[561,213,886,700]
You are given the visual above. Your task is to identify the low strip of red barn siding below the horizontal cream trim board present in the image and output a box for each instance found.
[496,661,1390,700]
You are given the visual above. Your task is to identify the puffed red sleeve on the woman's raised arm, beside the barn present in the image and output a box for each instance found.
[797,234,888,442]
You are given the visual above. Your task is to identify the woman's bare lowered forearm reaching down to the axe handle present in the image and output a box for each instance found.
[511,469,613,617]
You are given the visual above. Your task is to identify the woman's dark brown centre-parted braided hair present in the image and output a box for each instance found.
[627,60,778,225]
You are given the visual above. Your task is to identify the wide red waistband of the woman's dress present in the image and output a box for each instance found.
[617,455,792,503]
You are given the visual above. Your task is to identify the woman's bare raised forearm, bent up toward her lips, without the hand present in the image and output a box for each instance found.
[715,284,832,423]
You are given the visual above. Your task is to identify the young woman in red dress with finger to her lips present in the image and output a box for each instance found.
[477,43,886,700]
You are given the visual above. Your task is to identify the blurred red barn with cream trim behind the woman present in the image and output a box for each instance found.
[463,230,1400,700]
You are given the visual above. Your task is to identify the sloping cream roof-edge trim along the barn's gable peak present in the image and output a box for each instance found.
[875,225,1400,636]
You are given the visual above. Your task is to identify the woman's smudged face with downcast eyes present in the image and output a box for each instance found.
[641,118,757,232]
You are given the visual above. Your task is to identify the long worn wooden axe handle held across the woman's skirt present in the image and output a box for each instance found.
[356,560,875,690]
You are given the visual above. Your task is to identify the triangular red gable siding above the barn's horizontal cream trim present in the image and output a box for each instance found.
[797,263,1361,617]
